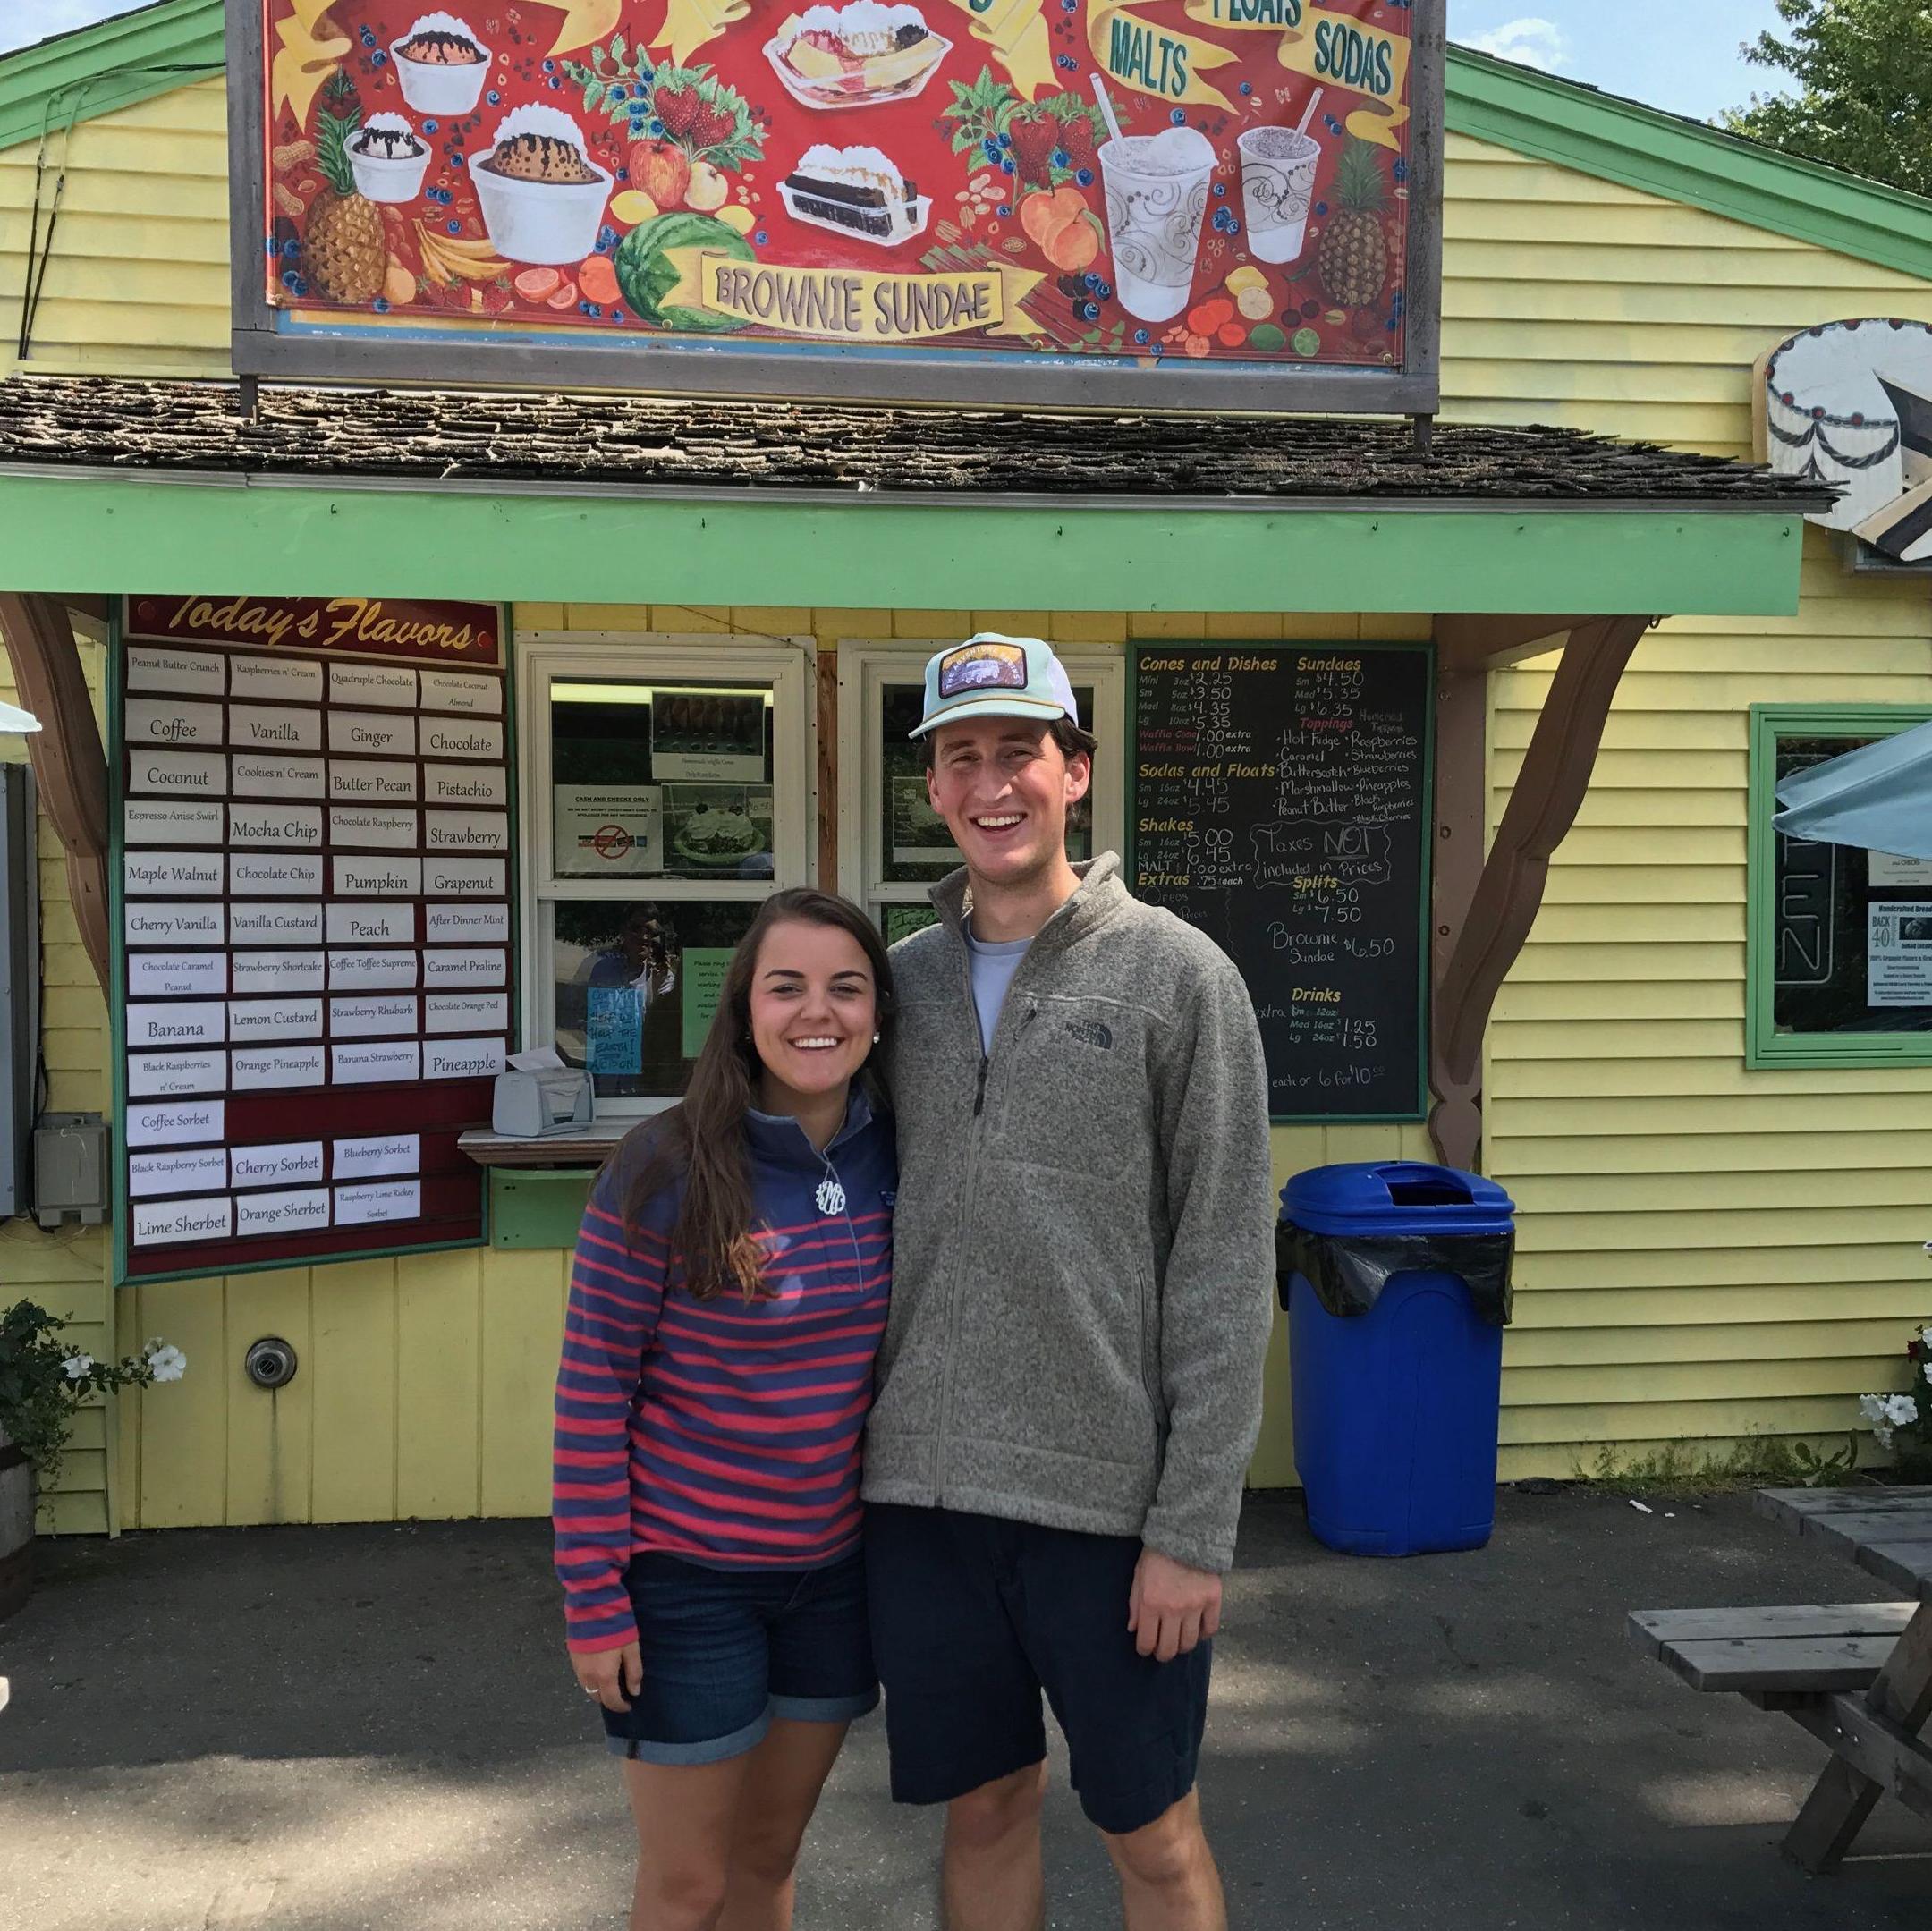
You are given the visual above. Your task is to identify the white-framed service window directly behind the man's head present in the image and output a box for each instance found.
[838,639,1126,943]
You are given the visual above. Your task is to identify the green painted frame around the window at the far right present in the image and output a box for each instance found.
[1744,705,1932,1071]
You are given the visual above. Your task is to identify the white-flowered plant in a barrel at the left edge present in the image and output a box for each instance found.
[0,1301,188,1616]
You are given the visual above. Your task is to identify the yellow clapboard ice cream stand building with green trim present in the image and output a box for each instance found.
[0,0,1932,1531]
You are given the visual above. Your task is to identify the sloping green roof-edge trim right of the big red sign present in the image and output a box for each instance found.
[1447,47,1932,280]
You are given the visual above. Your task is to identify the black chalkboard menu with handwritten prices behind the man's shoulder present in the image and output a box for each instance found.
[1128,645,1432,1120]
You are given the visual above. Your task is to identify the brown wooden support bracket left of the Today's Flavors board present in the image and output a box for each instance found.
[0,593,108,995]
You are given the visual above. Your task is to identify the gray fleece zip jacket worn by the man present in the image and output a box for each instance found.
[866,853,1275,1570]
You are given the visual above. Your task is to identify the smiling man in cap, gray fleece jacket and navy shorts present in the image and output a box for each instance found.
[866,631,1273,1931]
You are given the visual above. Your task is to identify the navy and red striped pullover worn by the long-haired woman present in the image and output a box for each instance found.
[551,1089,896,1651]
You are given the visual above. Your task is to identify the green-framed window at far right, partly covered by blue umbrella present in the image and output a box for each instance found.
[1744,705,1932,1068]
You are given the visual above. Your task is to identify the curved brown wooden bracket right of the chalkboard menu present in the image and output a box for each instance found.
[1429,616,1656,1168]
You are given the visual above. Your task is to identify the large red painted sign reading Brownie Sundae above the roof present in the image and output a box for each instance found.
[230,0,1441,408]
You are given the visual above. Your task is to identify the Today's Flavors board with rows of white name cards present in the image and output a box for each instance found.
[112,597,512,1283]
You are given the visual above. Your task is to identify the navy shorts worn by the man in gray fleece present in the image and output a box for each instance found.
[866,1503,1213,1836]
